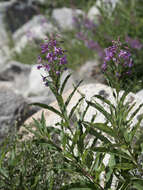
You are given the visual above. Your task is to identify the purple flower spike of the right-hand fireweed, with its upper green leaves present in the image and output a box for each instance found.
[101,39,134,92]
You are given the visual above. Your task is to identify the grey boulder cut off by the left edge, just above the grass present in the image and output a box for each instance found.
[0,85,28,142]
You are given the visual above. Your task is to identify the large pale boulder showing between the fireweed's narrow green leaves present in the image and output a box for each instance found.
[20,83,143,140]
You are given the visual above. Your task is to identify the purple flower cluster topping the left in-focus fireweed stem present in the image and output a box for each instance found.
[37,36,67,85]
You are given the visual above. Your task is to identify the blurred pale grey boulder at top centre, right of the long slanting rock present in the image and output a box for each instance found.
[52,7,83,30]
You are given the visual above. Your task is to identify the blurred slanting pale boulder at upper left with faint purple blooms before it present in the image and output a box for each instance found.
[13,15,56,53]
